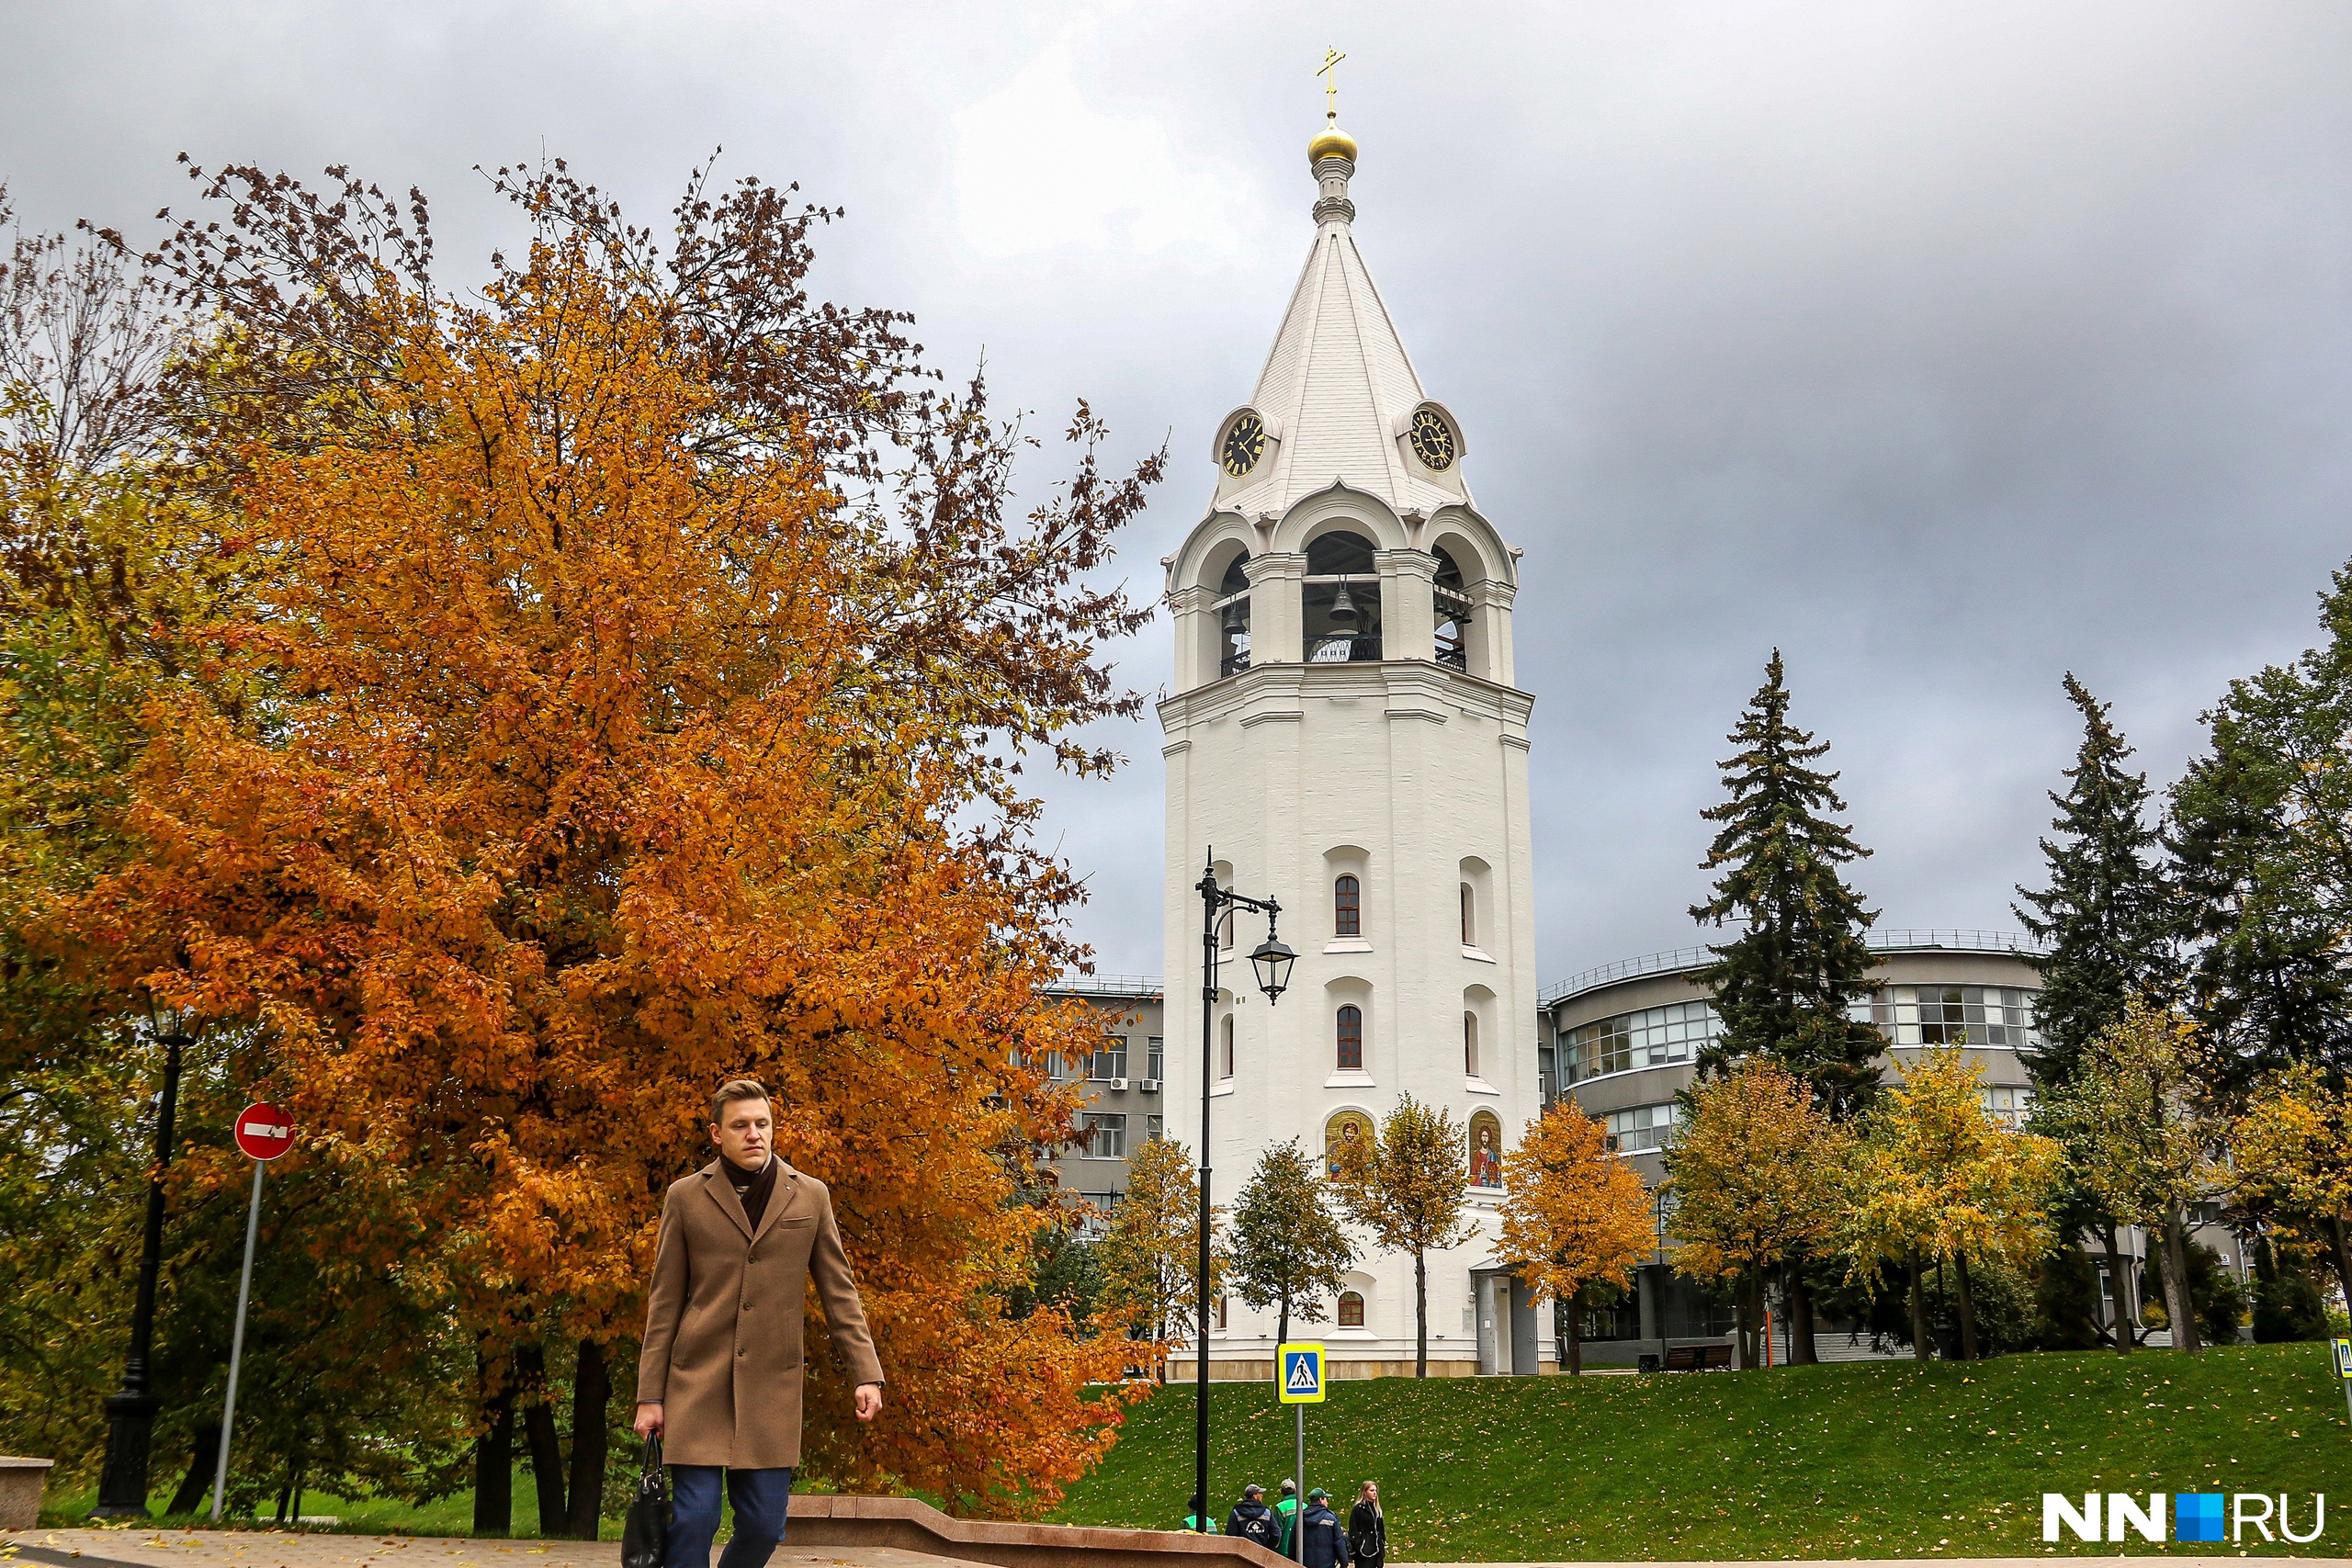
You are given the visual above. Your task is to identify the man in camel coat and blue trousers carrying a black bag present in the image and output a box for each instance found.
[638,1079,882,1568]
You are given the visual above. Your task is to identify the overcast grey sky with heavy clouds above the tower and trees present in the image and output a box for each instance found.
[0,0,2352,980]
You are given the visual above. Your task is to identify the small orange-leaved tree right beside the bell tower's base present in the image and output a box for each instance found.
[1496,1100,1658,1373]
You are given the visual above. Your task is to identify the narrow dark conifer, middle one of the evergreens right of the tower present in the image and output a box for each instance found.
[2011,672,2178,1090]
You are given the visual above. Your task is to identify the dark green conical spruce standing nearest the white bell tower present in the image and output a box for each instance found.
[1691,649,1886,1119]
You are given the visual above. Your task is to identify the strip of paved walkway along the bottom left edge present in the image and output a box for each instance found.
[0,1530,965,1568]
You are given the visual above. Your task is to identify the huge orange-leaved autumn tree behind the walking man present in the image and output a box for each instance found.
[71,164,1159,1533]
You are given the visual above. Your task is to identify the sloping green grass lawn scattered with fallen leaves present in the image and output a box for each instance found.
[1056,1345,2352,1563]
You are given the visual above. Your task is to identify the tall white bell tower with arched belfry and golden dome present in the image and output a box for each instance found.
[1159,113,1553,1378]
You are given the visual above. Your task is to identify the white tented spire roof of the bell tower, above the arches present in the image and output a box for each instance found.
[1218,118,1470,514]
